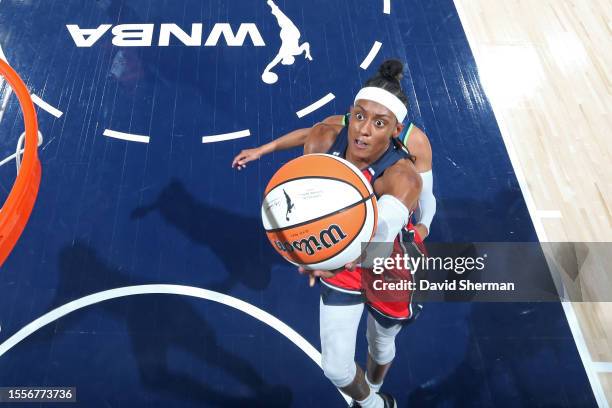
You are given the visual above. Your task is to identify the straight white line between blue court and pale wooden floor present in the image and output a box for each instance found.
[454,1,609,408]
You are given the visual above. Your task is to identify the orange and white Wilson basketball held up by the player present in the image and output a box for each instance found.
[261,154,377,270]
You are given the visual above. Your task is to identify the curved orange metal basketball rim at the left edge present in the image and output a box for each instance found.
[0,59,41,266]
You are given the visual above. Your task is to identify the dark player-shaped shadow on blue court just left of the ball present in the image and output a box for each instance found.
[132,180,283,292]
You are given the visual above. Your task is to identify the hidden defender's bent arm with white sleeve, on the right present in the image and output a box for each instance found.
[408,126,436,239]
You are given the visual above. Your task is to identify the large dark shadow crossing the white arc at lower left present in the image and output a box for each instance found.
[53,242,292,407]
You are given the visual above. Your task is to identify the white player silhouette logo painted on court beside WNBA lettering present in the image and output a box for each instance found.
[261,0,312,84]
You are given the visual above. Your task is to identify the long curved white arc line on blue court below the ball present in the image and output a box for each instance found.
[0,285,351,404]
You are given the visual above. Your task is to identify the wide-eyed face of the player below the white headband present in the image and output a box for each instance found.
[348,100,403,161]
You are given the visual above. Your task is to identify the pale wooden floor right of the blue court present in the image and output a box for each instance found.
[455,0,612,406]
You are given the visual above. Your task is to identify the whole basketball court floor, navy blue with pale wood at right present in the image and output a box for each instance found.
[0,0,612,407]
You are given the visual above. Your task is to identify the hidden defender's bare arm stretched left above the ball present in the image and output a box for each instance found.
[232,115,343,170]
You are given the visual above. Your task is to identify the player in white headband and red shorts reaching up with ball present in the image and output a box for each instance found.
[234,60,431,408]
